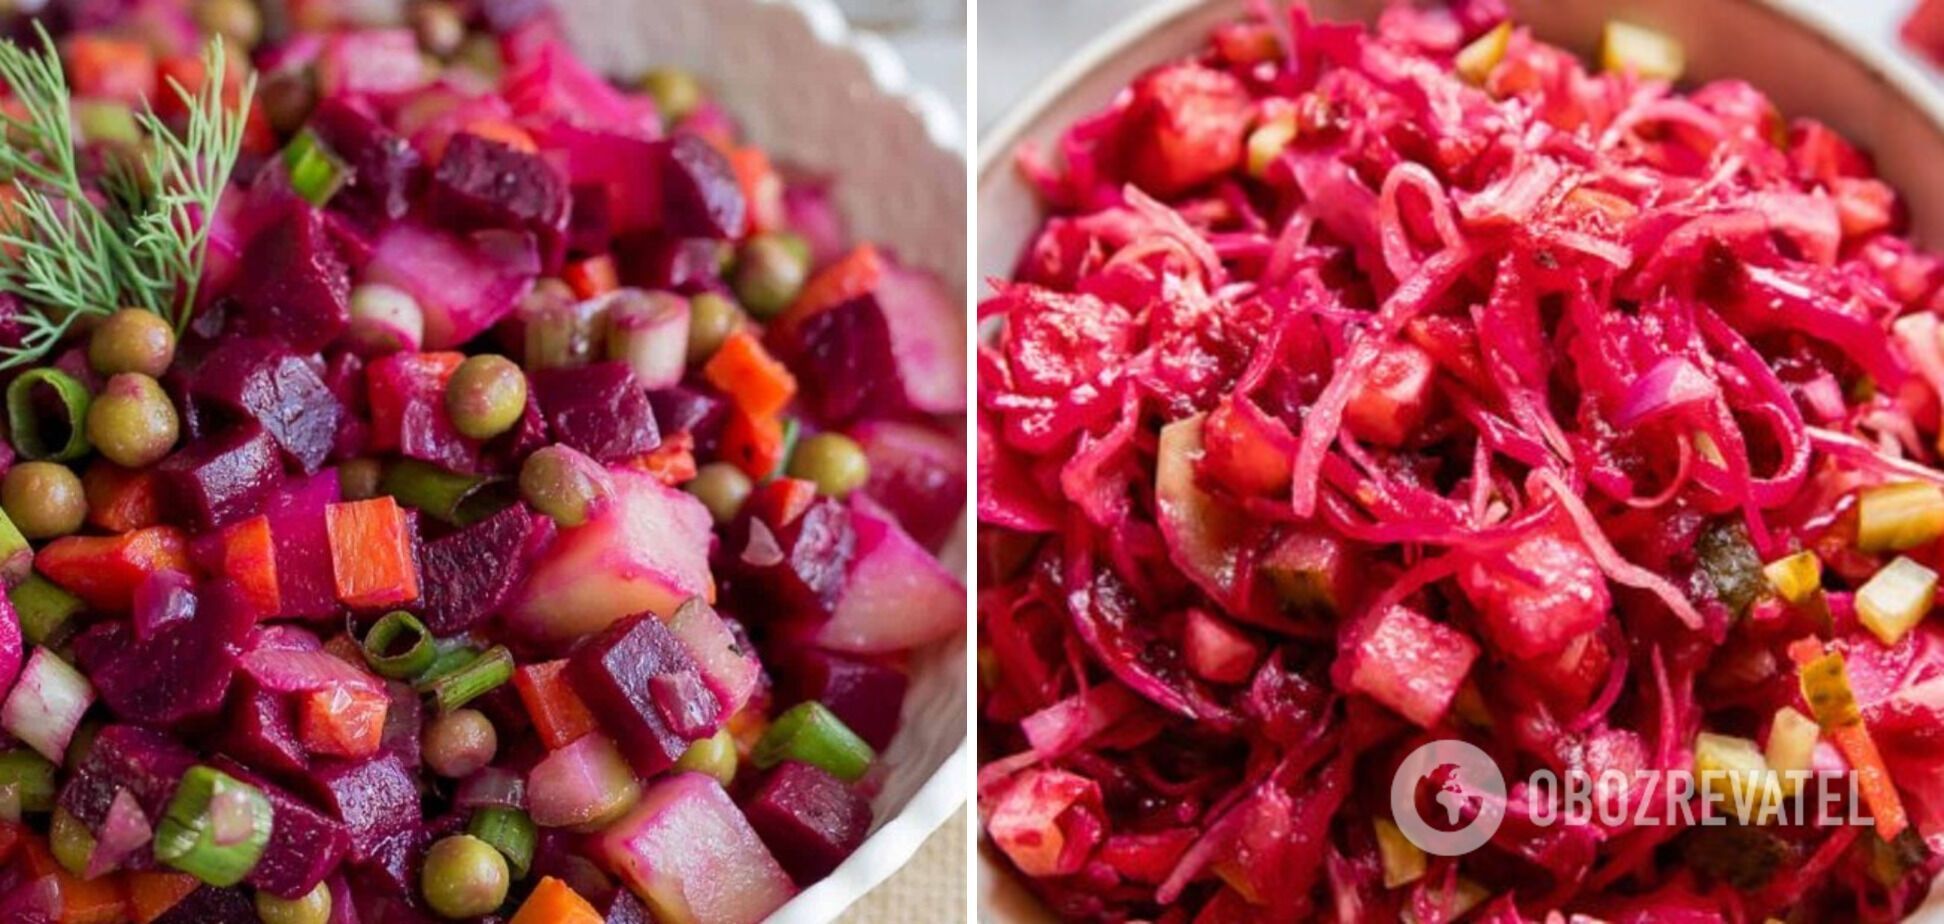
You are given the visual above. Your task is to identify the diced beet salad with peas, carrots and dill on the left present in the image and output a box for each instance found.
[0,0,966,924]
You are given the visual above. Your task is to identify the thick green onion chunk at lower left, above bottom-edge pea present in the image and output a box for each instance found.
[156,766,276,889]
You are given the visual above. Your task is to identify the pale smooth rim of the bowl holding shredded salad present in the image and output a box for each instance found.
[970,0,1944,924]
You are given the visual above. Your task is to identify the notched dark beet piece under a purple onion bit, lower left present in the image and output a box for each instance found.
[74,578,257,726]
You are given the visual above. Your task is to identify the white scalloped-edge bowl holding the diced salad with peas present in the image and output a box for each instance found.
[560,0,972,924]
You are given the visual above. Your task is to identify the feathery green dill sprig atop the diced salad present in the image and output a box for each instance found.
[0,23,257,370]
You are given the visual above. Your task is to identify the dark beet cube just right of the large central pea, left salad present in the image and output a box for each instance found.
[533,362,661,461]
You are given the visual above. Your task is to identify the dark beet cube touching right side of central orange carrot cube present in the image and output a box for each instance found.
[420,504,537,636]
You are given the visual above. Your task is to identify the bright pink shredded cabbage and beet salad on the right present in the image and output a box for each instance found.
[976,0,1944,924]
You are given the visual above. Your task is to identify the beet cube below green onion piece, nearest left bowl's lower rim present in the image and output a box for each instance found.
[743,761,871,885]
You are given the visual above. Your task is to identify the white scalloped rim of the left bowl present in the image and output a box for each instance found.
[756,0,972,924]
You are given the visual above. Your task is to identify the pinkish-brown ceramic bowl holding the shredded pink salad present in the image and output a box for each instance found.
[976,0,1944,924]
